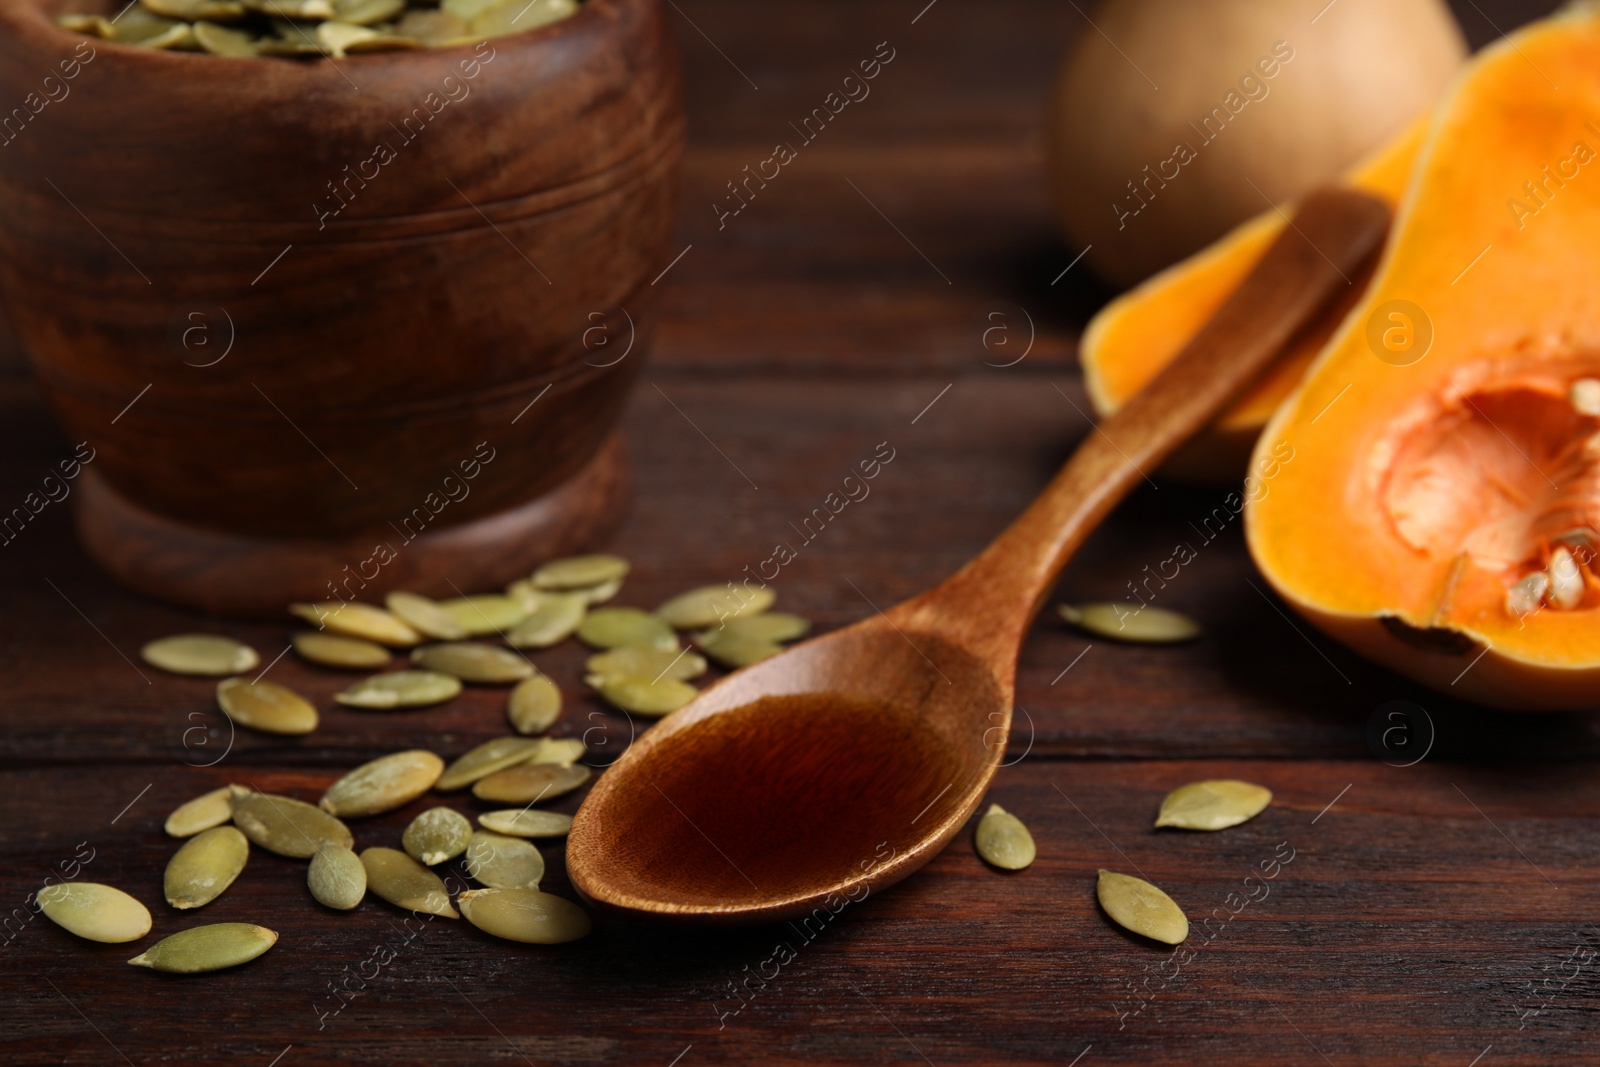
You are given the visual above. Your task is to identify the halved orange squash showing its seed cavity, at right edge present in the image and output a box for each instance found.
[1246,8,1600,710]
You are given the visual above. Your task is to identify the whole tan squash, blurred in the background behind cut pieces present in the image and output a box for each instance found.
[1050,0,1466,286]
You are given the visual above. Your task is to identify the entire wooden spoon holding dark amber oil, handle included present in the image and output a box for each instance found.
[566,190,1389,923]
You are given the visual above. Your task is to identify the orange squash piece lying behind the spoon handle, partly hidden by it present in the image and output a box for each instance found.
[1078,117,1427,483]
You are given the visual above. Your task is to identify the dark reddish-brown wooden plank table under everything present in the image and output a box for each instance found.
[0,0,1600,1067]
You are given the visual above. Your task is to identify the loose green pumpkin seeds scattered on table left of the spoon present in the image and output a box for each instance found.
[40,559,806,974]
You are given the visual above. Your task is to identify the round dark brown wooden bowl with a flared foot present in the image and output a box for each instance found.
[0,0,683,614]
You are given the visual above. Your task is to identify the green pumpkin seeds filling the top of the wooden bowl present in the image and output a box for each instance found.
[58,0,579,59]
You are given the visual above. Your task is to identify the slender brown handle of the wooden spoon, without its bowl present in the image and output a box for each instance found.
[899,189,1389,664]
